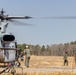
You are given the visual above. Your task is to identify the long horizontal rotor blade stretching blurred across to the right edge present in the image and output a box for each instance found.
[0,15,76,21]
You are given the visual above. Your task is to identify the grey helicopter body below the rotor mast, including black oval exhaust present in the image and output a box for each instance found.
[0,33,17,63]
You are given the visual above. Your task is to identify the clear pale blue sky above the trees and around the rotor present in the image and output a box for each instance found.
[0,0,76,45]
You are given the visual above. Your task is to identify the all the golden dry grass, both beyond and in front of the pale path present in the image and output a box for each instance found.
[2,56,76,75]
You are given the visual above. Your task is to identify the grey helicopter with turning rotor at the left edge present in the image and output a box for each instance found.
[0,9,35,63]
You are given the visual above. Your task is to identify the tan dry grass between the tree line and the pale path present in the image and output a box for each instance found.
[30,56,74,67]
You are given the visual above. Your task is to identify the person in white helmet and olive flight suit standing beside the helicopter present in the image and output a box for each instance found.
[24,46,31,67]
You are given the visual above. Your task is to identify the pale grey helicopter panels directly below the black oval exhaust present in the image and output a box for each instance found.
[4,42,16,62]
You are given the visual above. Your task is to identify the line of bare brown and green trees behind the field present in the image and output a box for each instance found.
[17,41,76,56]
